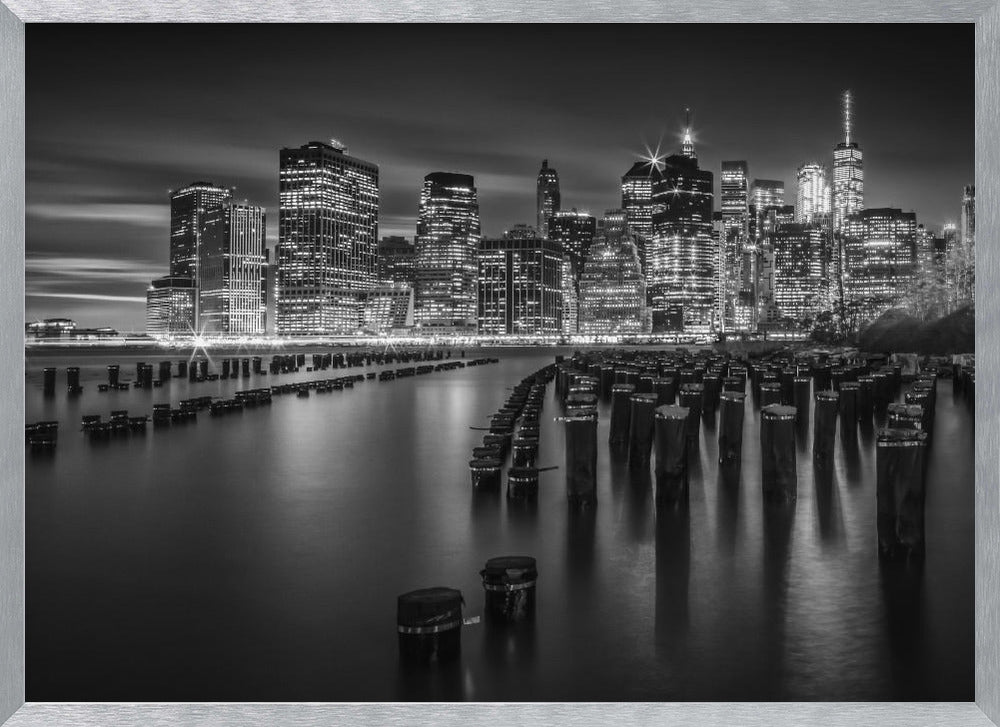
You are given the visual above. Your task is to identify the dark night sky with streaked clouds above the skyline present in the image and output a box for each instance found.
[25,24,975,330]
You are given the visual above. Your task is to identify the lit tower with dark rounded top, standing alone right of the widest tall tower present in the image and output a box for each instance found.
[414,172,480,333]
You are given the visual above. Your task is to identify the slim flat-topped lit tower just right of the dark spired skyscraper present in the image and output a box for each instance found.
[719,161,753,331]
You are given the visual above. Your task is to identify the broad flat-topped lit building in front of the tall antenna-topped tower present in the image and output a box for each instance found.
[843,208,917,323]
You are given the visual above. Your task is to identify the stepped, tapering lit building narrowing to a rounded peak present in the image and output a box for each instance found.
[580,225,651,335]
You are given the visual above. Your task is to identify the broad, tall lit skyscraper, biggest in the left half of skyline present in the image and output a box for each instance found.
[275,141,379,336]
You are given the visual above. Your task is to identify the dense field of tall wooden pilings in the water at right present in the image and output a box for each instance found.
[556,350,952,559]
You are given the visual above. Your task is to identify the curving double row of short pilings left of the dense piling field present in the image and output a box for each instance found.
[469,366,554,502]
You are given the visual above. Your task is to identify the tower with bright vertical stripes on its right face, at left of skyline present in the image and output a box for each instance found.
[198,202,267,336]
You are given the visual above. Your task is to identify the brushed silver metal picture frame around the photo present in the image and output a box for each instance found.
[0,0,1000,727]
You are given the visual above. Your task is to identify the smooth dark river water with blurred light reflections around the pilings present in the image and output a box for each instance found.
[26,349,974,701]
